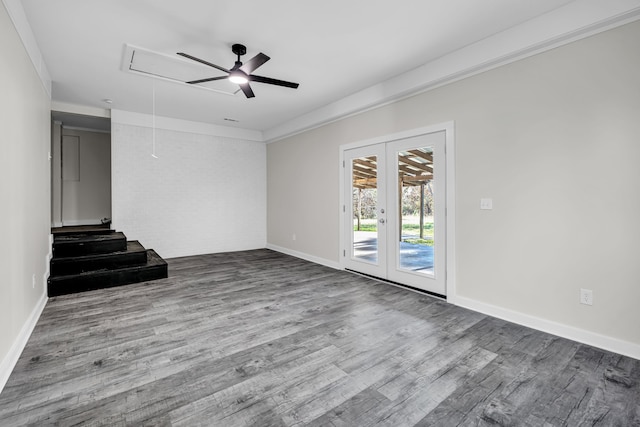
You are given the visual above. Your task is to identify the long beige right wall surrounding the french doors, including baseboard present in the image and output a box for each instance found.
[267,22,640,357]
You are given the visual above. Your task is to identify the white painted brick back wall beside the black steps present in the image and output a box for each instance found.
[111,111,266,258]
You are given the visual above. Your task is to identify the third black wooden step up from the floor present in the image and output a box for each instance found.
[53,232,127,258]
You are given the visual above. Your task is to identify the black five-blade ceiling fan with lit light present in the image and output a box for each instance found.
[178,44,299,98]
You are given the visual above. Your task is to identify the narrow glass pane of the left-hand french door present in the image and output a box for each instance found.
[351,156,378,263]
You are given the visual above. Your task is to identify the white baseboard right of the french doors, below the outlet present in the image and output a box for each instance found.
[456,296,640,360]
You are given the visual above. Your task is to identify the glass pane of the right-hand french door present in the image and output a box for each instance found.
[396,147,435,275]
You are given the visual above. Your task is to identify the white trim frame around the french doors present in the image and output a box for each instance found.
[338,121,456,303]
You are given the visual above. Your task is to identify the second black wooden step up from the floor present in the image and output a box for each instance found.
[51,240,147,276]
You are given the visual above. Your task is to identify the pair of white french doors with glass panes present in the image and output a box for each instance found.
[343,131,446,295]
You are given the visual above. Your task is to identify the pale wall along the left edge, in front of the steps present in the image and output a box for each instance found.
[0,5,51,390]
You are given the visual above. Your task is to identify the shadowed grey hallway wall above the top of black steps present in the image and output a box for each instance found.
[60,126,111,225]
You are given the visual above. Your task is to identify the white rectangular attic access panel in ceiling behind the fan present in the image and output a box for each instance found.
[121,44,240,95]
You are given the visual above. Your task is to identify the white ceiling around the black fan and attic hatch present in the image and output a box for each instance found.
[12,0,639,136]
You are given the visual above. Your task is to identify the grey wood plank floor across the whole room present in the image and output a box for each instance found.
[0,249,640,427]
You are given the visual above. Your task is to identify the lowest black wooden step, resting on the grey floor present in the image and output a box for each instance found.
[48,249,168,297]
